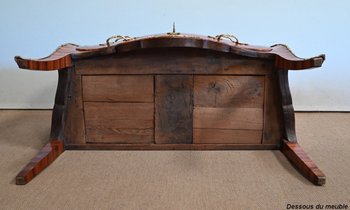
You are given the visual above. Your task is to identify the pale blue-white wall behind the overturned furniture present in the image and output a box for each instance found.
[0,0,350,111]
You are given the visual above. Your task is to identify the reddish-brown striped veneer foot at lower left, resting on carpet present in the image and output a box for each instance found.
[16,140,64,185]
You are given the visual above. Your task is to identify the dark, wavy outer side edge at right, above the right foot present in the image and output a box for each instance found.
[278,70,297,142]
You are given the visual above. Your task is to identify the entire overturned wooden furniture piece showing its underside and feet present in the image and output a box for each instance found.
[15,33,325,185]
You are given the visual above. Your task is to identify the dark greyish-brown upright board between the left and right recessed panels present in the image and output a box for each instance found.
[155,75,193,144]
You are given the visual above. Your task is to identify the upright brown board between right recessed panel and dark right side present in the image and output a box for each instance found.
[262,72,284,144]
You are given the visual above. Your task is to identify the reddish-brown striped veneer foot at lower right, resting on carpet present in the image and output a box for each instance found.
[281,141,326,186]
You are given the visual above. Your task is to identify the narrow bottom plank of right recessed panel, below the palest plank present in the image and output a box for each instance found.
[193,128,262,144]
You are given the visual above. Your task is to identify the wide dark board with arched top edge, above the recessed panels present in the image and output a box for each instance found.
[75,48,274,75]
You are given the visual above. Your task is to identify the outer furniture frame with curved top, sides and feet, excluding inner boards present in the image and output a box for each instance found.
[15,33,325,185]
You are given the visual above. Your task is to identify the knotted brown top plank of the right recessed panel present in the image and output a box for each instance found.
[194,76,264,108]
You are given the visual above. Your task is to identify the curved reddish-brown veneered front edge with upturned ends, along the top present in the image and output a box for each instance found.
[15,34,325,70]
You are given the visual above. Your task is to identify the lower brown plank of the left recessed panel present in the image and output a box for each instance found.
[84,102,154,143]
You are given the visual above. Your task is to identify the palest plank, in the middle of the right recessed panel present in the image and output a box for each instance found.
[193,107,263,130]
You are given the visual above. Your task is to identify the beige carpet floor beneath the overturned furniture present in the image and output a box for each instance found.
[0,111,350,210]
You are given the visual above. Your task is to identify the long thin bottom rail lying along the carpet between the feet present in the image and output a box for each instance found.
[66,143,279,150]
